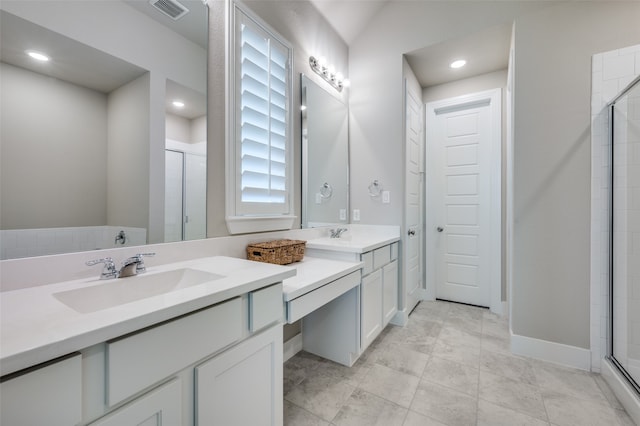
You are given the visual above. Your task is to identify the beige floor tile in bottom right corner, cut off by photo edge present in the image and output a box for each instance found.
[543,391,620,426]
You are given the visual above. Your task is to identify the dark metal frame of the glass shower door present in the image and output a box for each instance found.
[606,76,640,395]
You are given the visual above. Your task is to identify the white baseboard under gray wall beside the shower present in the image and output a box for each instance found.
[511,333,591,371]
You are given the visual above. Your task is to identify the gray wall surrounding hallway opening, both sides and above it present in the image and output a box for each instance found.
[349,1,640,348]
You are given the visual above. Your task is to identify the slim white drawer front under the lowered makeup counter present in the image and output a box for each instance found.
[287,271,361,324]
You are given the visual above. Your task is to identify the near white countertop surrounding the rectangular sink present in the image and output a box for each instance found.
[0,256,296,375]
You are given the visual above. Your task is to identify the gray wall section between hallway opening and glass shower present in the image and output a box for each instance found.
[512,2,640,348]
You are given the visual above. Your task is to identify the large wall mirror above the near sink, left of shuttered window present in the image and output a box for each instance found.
[0,0,208,259]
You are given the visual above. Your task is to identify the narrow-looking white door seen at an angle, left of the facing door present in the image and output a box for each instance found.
[400,78,424,314]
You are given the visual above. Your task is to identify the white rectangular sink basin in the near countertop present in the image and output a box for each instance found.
[54,268,224,314]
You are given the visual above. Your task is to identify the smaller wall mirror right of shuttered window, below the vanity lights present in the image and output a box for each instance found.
[301,75,349,228]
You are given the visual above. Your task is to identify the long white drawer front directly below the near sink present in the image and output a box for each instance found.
[106,297,242,406]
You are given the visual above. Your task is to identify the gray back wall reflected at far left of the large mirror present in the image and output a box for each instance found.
[0,63,107,229]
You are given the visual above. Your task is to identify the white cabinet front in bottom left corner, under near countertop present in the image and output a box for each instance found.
[0,353,82,426]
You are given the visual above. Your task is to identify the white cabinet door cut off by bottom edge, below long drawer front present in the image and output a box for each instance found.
[91,379,182,426]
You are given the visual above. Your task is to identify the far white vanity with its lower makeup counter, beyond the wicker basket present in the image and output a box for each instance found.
[284,226,399,366]
